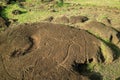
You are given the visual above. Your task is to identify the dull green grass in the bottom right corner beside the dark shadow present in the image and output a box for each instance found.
[97,59,120,80]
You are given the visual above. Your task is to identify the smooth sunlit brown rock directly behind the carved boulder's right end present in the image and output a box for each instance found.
[82,21,120,45]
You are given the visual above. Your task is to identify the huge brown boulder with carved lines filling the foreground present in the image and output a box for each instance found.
[0,23,103,80]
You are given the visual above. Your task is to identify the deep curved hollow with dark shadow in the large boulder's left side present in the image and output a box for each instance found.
[11,32,40,57]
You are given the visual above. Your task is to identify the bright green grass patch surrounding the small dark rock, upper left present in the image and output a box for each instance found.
[1,3,50,23]
